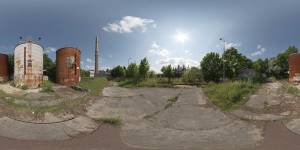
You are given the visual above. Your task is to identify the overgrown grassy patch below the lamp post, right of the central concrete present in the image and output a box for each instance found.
[202,81,259,111]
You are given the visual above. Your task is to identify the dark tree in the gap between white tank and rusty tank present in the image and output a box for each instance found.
[43,54,56,81]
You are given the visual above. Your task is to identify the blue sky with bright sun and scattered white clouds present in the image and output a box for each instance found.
[0,0,300,72]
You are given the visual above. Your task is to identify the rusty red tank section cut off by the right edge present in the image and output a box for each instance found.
[288,53,300,83]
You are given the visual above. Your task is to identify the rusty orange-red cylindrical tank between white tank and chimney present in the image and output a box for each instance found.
[56,47,80,85]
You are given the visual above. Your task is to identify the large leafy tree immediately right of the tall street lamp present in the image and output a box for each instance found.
[223,47,252,79]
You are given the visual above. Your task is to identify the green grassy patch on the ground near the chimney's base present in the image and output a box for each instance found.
[76,78,107,96]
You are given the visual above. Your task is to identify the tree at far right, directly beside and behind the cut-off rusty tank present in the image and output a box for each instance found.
[269,46,298,79]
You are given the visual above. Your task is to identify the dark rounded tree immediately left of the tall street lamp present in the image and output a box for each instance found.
[200,52,223,82]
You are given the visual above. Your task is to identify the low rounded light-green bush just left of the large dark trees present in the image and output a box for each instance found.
[182,67,203,84]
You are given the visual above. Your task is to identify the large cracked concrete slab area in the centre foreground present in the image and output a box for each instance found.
[87,87,263,149]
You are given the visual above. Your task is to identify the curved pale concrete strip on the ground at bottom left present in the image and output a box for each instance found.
[0,116,98,141]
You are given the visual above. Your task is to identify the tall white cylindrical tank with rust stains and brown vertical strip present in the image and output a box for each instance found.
[14,41,43,88]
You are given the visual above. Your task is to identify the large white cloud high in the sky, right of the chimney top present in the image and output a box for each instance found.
[102,16,156,33]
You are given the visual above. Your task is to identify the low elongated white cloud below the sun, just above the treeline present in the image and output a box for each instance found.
[157,57,199,67]
